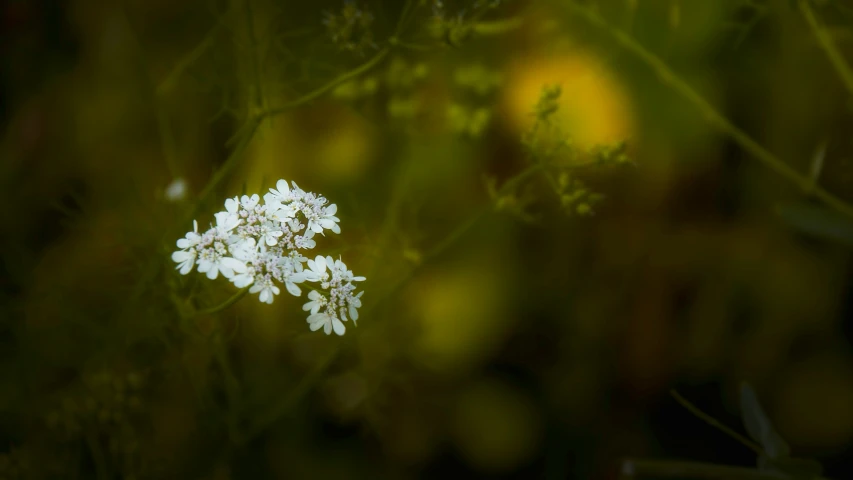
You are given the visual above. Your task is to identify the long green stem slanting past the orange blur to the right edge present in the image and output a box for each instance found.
[562,1,853,219]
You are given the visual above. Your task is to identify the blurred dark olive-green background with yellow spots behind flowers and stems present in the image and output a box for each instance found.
[5,0,853,479]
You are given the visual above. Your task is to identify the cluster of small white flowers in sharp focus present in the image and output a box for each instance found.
[172,180,365,335]
